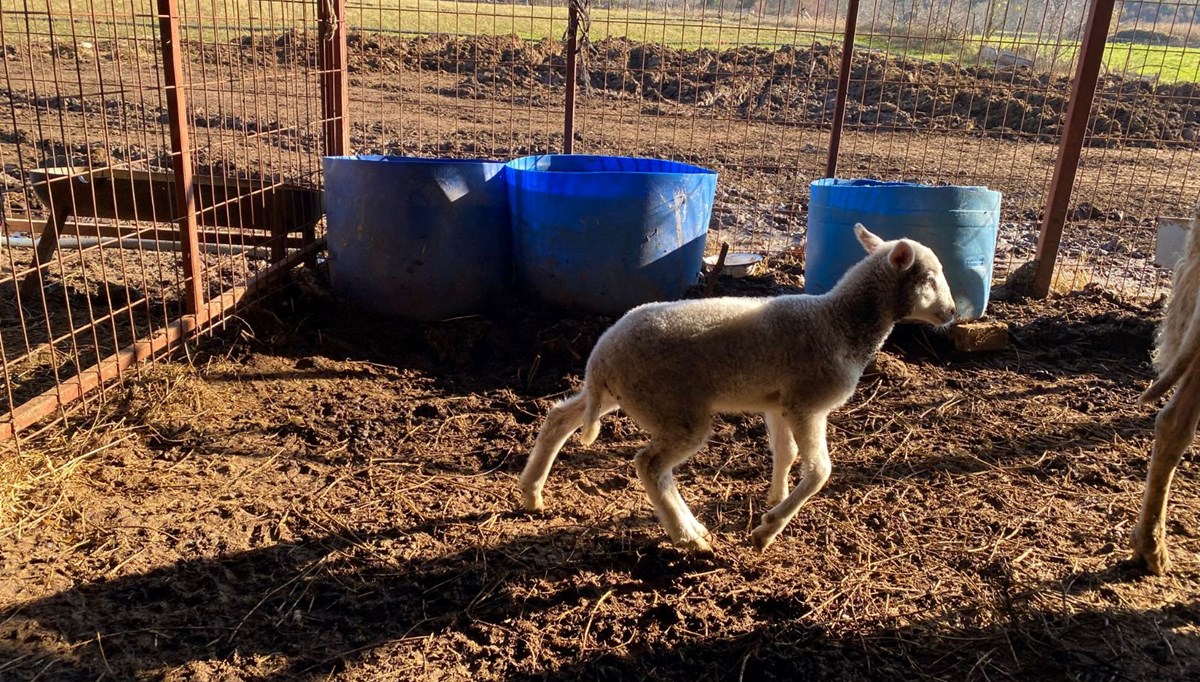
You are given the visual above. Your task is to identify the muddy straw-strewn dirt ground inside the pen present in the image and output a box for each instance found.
[0,258,1200,681]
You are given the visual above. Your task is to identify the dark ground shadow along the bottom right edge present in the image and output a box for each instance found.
[532,562,1200,682]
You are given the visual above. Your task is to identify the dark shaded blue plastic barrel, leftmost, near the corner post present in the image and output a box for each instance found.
[324,156,512,321]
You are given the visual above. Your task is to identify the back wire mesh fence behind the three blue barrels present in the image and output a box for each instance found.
[338,0,1198,297]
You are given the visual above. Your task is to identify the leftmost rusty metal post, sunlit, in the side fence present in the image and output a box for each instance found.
[158,0,204,315]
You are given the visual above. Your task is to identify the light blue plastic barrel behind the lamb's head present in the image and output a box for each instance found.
[804,178,1000,319]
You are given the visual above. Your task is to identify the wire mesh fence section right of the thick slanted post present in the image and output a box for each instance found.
[1056,2,1200,298]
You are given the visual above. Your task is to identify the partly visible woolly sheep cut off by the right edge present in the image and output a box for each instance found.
[1133,195,1200,575]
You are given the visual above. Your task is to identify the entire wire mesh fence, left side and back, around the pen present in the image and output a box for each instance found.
[7,0,1200,444]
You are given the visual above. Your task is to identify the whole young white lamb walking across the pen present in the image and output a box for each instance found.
[520,225,955,554]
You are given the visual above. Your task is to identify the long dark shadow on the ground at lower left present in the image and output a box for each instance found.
[0,514,710,681]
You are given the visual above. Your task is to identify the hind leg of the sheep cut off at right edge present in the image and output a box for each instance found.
[1133,359,1200,575]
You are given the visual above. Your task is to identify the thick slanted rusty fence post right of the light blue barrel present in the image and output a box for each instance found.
[1030,0,1115,298]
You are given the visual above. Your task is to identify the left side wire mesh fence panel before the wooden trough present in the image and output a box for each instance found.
[0,0,322,446]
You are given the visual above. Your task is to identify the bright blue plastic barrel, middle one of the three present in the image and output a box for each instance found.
[508,155,716,315]
